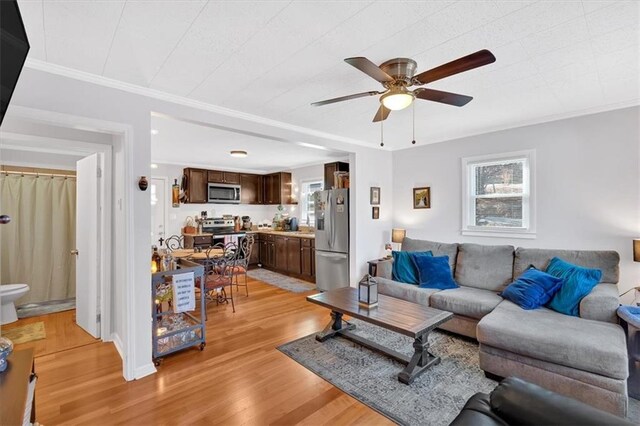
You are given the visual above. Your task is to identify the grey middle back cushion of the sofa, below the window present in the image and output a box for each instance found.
[454,244,519,292]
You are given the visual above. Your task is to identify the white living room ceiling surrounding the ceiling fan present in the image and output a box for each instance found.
[19,0,640,148]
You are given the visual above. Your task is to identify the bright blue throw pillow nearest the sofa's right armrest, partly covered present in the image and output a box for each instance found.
[547,257,602,317]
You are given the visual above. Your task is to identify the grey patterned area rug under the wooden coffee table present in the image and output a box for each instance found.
[278,320,640,425]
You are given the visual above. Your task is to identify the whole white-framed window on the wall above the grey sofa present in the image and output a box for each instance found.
[462,150,535,238]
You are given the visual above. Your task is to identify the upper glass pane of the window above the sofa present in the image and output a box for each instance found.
[475,161,524,195]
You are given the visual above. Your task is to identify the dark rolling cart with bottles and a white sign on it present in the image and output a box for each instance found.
[151,259,206,366]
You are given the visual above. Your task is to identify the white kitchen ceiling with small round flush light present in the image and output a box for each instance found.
[151,115,348,173]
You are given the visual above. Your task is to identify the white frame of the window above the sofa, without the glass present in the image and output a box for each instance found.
[461,149,536,239]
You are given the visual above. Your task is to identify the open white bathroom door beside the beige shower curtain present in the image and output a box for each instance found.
[72,154,101,338]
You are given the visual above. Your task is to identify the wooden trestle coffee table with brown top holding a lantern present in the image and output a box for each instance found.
[307,287,453,384]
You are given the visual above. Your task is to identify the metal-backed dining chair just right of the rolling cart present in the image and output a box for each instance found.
[200,243,239,319]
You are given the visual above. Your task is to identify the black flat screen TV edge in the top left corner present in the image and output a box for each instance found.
[0,0,29,125]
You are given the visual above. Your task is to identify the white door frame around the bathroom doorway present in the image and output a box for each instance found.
[3,105,136,380]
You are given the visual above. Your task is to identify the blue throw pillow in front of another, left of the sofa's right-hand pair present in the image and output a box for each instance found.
[500,268,562,309]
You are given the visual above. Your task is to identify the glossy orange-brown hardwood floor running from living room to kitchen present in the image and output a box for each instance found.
[26,280,391,425]
